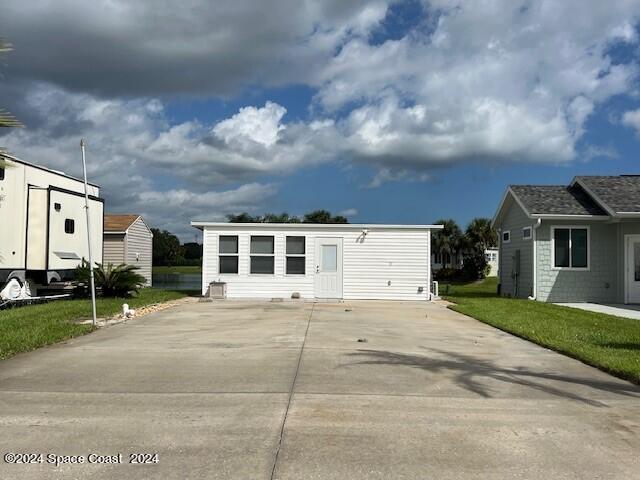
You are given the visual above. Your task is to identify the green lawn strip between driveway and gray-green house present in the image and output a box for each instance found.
[440,278,640,384]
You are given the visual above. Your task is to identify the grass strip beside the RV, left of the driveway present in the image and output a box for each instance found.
[0,288,187,359]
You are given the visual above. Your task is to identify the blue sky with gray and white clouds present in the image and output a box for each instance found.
[0,0,640,239]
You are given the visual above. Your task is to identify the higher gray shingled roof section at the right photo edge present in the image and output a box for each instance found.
[576,175,640,213]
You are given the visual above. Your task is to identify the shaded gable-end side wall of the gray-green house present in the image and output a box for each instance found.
[498,200,534,298]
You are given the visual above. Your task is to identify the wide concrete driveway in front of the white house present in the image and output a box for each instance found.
[0,302,640,480]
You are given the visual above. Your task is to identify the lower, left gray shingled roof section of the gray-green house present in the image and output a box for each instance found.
[511,185,607,215]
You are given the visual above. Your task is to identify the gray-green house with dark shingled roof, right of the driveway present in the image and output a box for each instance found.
[493,175,640,303]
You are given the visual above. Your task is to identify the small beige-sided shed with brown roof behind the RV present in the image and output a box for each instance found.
[104,215,153,287]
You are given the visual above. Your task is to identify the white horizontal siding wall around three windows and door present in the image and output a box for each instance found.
[202,226,430,300]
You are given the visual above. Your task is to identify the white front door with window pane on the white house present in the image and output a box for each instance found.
[315,238,342,298]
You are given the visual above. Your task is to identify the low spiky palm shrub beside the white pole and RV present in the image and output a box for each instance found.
[76,261,145,297]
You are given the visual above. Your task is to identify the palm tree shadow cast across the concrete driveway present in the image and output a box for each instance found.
[348,347,640,407]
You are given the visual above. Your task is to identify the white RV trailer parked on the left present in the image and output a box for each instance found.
[0,153,104,285]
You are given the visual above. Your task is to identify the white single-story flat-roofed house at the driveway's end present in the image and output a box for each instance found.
[191,221,441,300]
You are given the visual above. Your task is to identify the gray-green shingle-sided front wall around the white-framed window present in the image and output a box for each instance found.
[536,221,619,302]
